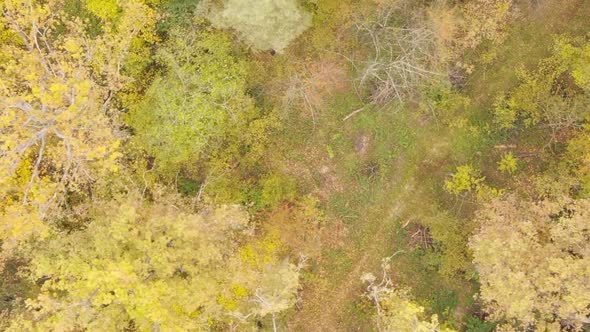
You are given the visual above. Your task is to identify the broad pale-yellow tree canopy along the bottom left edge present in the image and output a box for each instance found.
[9,193,298,331]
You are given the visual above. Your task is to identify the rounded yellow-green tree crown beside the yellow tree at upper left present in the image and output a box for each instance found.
[127,22,275,176]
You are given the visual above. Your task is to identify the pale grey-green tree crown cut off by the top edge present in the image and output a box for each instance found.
[205,0,311,52]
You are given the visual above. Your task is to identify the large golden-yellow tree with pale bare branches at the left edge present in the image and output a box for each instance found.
[0,0,155,250]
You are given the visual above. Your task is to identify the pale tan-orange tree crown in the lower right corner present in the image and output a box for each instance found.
[470,196,590,330]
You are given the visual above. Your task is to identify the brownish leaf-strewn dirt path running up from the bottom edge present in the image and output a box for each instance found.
[289,179,412,332]
